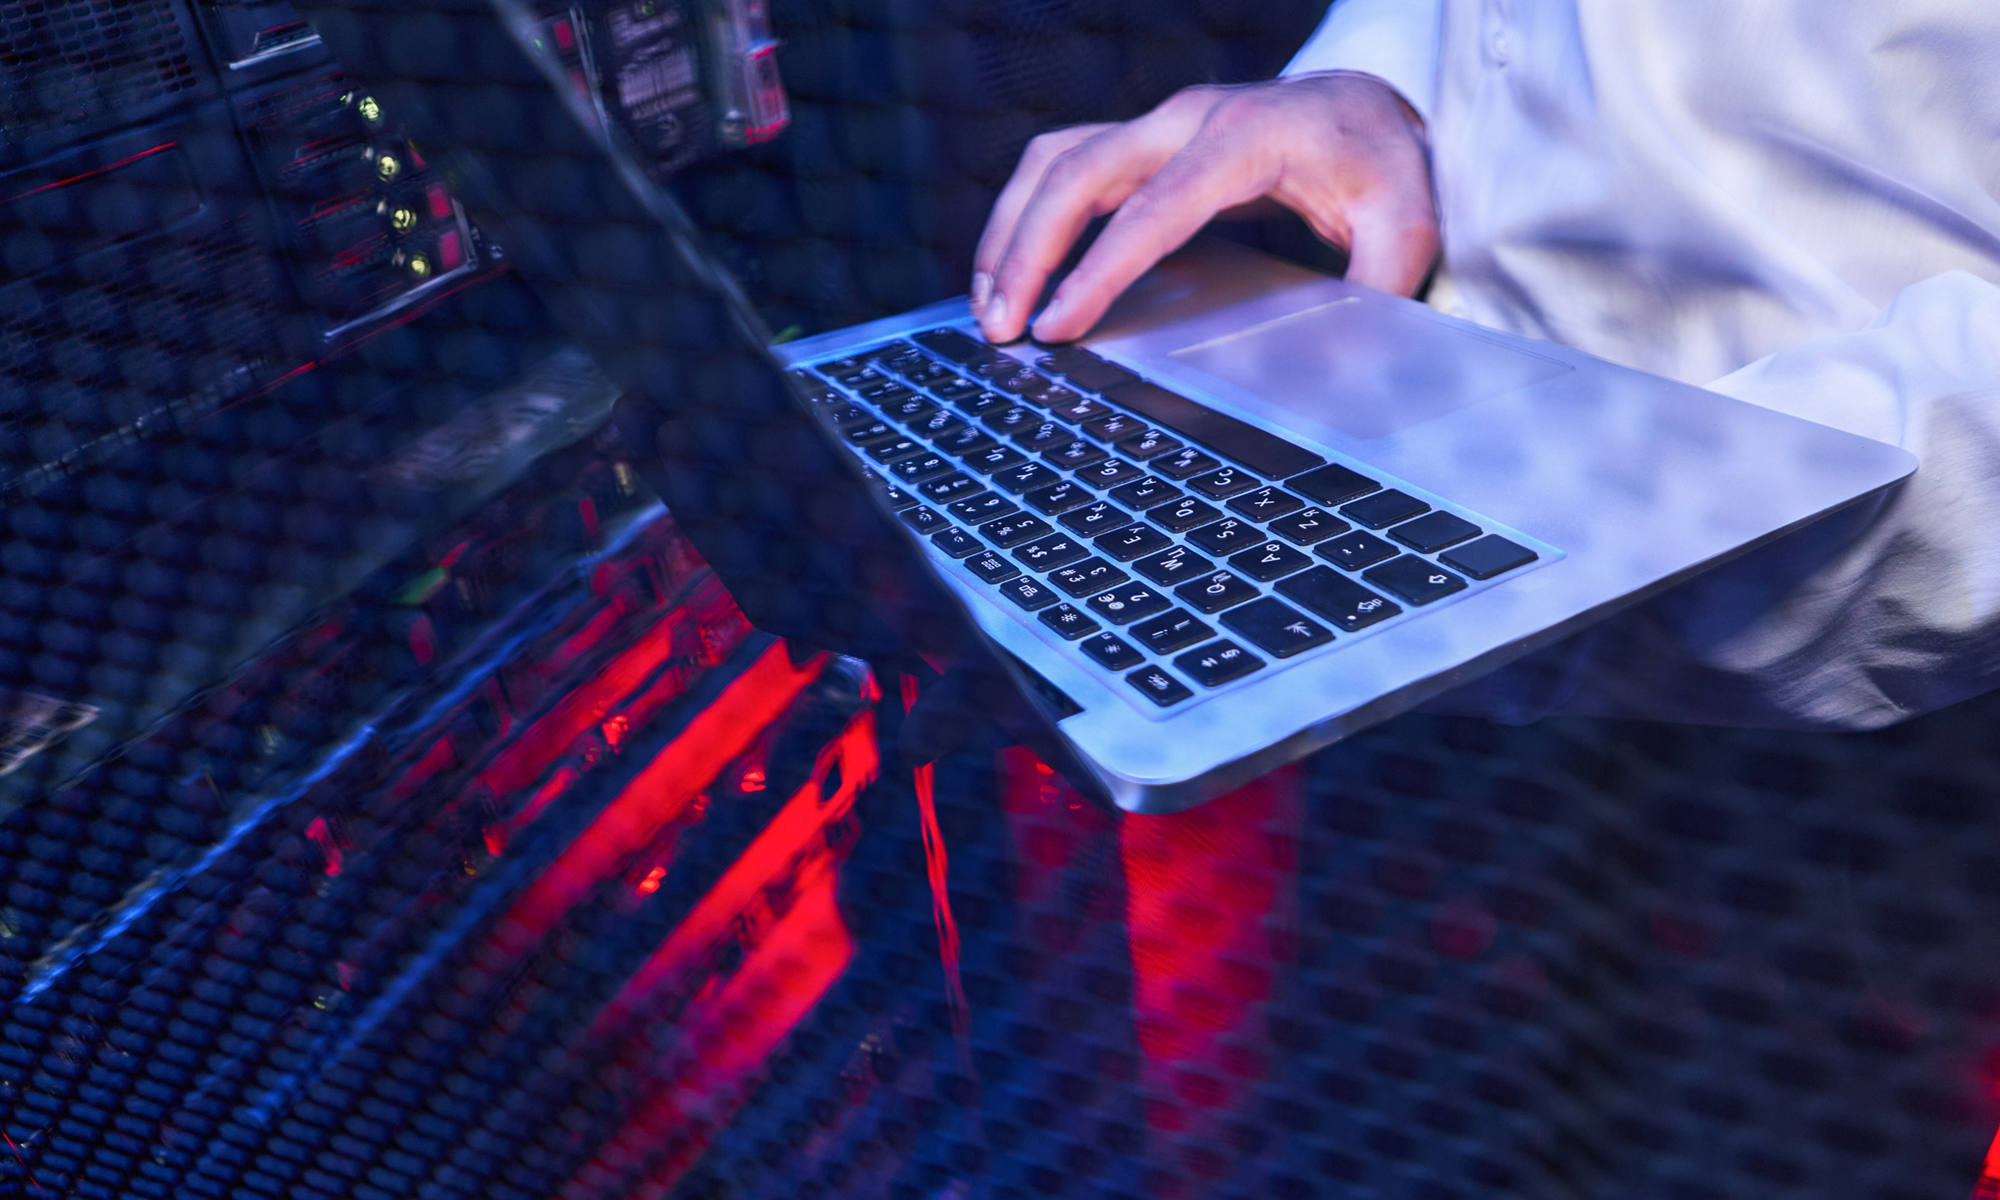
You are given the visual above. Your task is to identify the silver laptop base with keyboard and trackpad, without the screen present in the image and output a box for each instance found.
[780,242,1916,812]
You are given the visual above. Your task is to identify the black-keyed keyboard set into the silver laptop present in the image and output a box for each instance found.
[792,328,1536,710]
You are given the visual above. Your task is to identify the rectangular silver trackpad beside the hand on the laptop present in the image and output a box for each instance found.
[1170,298,1570,438]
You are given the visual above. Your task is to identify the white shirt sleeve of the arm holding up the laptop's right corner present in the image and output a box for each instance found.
[1434,272,2000,730]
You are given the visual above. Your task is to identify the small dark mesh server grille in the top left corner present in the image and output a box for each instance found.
[0,0,200,144]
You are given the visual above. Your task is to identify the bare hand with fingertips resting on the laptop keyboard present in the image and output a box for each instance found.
[972,72,1438,342]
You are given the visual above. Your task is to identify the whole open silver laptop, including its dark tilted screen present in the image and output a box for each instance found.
[302,0,1916,812]
